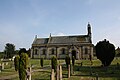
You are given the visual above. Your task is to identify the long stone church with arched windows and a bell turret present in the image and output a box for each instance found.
[31,23,94,59]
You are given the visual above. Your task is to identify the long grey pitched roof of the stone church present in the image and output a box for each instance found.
[33,35,89,44]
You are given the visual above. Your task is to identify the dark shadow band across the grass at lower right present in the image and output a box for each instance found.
[73,65,120,78]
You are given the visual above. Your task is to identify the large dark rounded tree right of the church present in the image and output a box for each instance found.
[95,39,115,66]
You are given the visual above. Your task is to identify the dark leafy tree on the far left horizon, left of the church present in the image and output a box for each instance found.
[4,43,15,58]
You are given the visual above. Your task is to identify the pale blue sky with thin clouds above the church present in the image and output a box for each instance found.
[0,0,120,51]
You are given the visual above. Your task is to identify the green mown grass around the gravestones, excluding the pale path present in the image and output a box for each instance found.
[0,58,120,80]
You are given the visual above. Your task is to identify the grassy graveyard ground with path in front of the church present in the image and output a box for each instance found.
[0,57,120,80]
